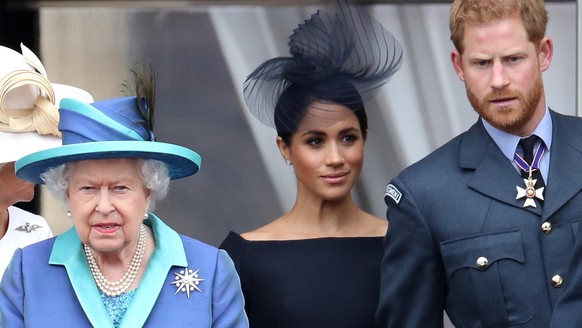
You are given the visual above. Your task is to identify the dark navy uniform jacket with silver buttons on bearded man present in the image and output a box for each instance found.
[376,111,582,328]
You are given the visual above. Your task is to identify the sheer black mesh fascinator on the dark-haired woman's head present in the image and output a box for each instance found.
[244,0,403,132]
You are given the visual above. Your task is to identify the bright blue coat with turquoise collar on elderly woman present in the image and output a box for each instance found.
[0,215,248,328]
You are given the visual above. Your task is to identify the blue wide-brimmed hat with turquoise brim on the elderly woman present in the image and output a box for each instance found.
[15,97,201,184]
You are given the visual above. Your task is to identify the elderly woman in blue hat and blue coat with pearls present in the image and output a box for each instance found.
[0,68,248,328]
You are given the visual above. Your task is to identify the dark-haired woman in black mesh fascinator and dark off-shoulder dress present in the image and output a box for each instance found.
[221,1,402,328]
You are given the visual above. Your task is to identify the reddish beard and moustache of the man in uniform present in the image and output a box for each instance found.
[465,74,543,133]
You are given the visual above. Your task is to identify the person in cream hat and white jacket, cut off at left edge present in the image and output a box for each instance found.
[0,45,93,279]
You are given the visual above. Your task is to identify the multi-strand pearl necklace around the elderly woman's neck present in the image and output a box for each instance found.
[83,224,146,297]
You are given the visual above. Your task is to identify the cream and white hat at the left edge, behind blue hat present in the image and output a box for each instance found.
[0,44,93,164]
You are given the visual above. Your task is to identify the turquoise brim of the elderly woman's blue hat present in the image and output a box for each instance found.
[15,140,202,184]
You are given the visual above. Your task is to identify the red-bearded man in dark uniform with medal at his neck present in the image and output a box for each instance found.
[377,0,582,328]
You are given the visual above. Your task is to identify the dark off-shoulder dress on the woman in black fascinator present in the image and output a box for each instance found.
[220,232,383,328]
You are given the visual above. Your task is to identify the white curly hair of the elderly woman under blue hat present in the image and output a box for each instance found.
[40,158,170,211]
